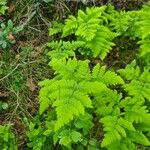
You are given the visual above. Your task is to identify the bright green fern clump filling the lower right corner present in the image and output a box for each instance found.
[94,64,150,150]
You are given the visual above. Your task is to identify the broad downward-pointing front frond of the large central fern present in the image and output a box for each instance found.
[40,79,92,130]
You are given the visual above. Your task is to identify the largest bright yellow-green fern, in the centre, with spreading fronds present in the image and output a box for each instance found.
[40,58,124,146]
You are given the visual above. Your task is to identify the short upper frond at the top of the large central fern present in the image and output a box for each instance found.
[50,58,90,81]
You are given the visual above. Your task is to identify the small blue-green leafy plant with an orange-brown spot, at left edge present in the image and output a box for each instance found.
[0,20,22,49]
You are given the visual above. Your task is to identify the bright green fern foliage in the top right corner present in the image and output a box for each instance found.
[110,3,150,66]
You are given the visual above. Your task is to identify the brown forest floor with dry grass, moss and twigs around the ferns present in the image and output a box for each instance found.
[0,0,149,149]
